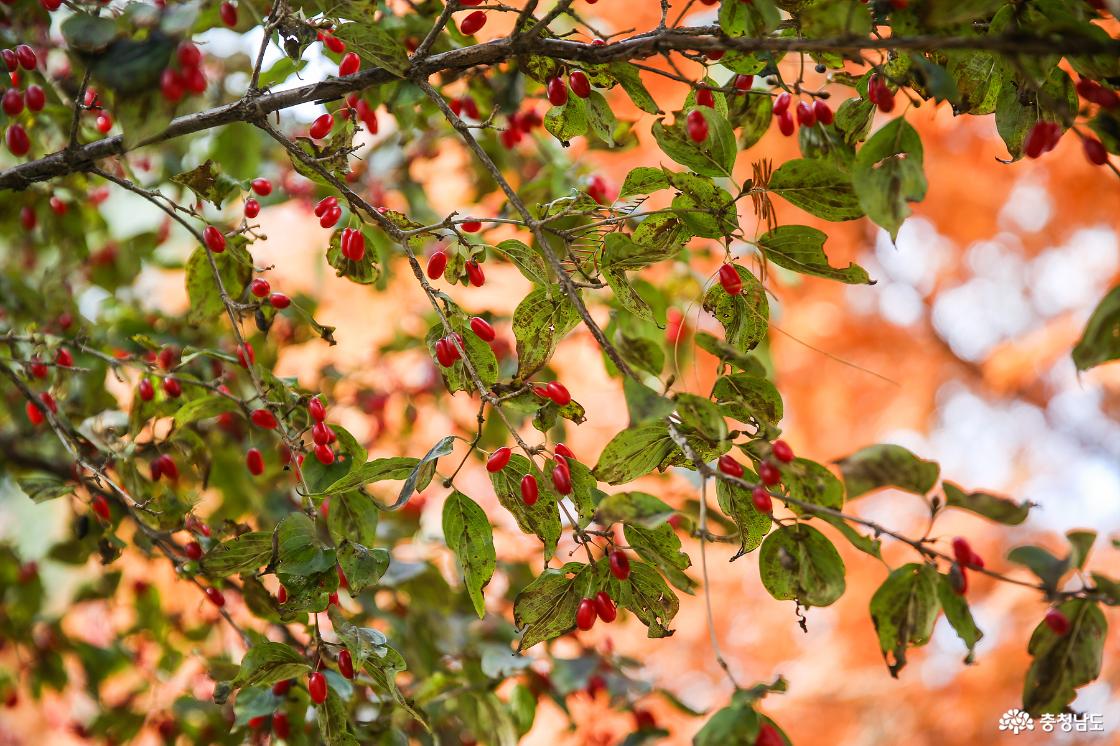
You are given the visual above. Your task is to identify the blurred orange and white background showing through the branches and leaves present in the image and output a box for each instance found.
[0,1,1120,746]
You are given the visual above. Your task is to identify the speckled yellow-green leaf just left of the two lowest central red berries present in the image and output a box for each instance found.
[513,562,591,651]
